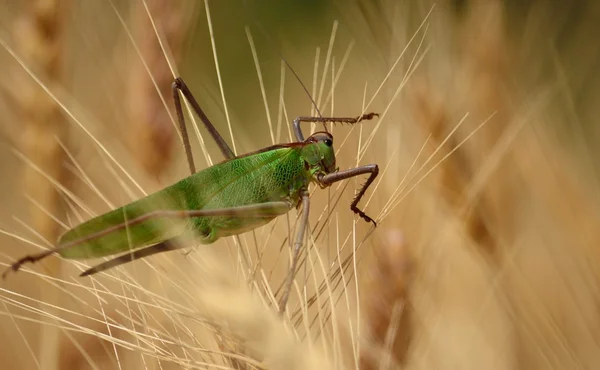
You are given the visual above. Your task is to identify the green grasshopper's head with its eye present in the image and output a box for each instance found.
[302,132,337,174]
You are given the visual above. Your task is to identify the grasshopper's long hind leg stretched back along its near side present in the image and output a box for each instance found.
[2,202,290,278]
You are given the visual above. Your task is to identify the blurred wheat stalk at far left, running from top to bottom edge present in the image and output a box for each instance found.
[14,0,68,369]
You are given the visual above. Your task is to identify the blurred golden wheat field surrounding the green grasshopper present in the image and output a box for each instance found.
[0,0,600,370]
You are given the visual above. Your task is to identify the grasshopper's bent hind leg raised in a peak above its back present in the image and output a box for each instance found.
[171,77,235,175]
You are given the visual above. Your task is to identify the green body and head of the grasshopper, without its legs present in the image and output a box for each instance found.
[58,133,335,259]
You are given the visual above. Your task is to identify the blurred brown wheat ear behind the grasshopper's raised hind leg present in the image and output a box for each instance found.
[126,0,191,177]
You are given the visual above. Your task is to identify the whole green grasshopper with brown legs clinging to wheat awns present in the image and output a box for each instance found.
[3,78,379,311]
